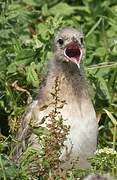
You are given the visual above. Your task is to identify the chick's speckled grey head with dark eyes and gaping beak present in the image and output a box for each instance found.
[54,28,85,67]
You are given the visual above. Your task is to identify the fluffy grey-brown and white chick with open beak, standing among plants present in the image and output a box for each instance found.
[15,27,98,171]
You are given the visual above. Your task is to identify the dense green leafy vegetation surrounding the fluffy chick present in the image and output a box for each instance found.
[0,0,117,180]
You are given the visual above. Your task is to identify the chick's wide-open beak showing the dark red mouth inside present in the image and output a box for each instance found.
[64,44,82,64]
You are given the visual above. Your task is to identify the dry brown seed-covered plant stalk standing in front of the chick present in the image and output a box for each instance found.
[20,77,70,179]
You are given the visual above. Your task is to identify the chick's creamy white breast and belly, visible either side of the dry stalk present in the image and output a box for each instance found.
[31,98,98,167]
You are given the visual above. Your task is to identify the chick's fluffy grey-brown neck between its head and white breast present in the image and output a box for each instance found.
[40,60,89,105]
